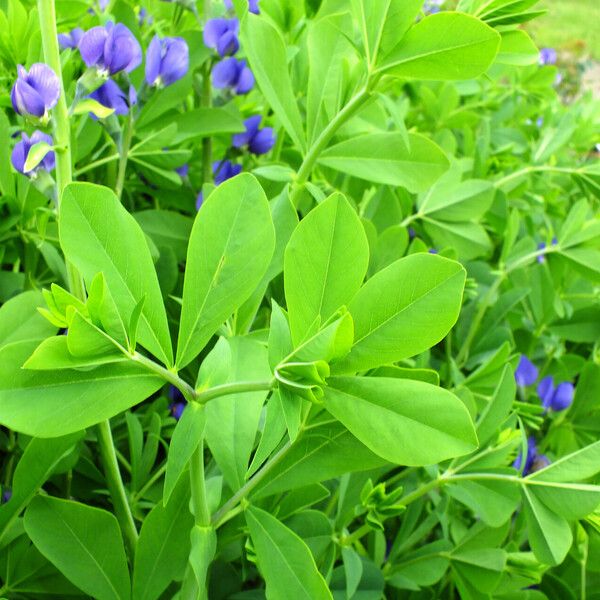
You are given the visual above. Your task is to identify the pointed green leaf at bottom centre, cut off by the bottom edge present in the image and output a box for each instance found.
[245,506,333,600]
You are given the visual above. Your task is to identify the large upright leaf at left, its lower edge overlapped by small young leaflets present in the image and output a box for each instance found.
[60,183,173,366]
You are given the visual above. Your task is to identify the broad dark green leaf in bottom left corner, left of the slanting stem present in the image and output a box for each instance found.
[24,496,130,600]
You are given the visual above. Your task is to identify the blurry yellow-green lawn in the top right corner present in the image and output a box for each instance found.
[526,0,600,60]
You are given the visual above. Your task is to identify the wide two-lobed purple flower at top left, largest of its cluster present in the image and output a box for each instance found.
[79,23,142,75]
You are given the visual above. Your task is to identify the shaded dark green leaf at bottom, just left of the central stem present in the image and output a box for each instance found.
[133,478,194,600]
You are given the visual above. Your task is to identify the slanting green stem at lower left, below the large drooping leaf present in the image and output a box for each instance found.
[96,421,138,560]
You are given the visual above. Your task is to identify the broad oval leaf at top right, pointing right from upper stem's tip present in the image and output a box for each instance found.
[379,12,500,80]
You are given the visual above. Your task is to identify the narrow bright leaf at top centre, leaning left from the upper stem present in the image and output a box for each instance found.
[241,14,306,152]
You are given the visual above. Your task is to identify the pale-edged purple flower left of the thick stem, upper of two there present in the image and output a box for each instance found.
[10,63,60,120]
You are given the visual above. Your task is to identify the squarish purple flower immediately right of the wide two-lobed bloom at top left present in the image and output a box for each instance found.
[146,35,190,87]
